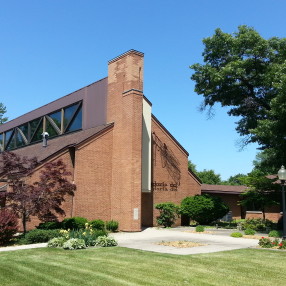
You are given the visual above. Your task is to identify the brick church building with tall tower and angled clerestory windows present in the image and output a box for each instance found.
[0,50,201,231]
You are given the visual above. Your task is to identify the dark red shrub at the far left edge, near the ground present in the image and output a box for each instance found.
[0,209,18,245]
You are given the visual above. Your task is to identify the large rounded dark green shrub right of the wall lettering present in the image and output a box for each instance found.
[181,194,229,224]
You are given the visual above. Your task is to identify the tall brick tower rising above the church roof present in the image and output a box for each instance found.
[107,50,144,231]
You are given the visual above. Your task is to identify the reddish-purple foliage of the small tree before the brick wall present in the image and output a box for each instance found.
[0,152,76,233]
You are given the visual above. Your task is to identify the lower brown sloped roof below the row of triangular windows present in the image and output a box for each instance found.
[2,123,113,162]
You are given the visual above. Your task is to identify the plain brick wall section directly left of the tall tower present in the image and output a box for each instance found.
[72,130,113,221]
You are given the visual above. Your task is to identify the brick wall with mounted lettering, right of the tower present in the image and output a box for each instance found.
[147,118,201,225]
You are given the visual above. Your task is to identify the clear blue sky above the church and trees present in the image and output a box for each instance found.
[0,0,286,179]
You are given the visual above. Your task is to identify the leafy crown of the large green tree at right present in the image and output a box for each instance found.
[191,26,286,167]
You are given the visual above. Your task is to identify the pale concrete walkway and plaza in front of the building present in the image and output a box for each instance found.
[0,227,258,255]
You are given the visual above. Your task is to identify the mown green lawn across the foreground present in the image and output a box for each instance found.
[0,247,286,286]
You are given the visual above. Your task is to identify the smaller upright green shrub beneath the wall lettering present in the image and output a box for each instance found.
[155,203,179,227]
